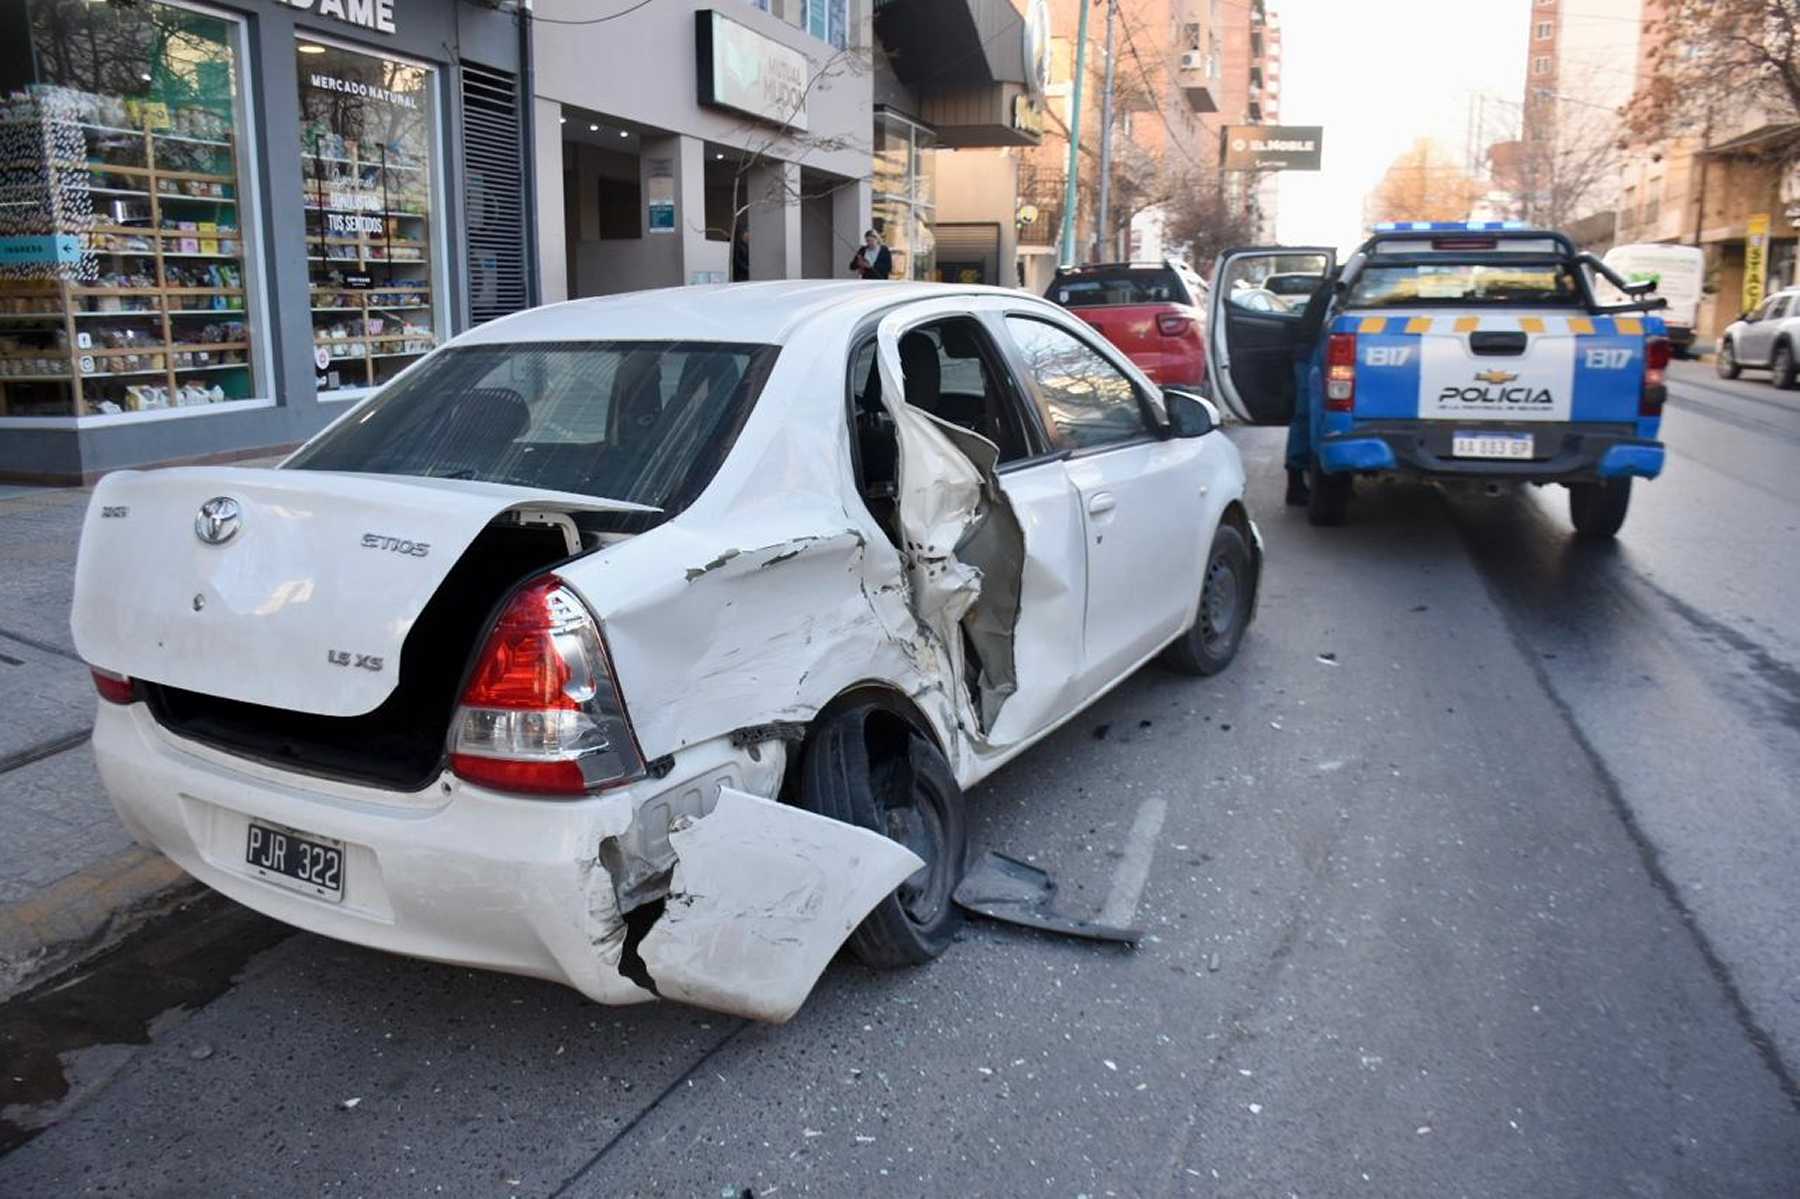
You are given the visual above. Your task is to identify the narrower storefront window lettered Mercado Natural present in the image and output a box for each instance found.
[297,38,439,394]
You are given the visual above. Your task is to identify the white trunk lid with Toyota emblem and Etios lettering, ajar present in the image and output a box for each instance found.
[70,468,653,717]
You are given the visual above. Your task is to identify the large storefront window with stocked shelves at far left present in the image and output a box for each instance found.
[0,0,261,416]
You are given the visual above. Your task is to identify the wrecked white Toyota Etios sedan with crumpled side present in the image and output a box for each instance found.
[74,283,1262,1021]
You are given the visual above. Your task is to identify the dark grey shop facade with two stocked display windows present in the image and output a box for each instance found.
[0,0,533,482]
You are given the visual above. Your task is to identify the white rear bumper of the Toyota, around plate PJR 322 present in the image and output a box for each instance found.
[94,702,781,1003]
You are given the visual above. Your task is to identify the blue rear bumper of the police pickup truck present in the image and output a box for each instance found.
[1318,421,1663,482]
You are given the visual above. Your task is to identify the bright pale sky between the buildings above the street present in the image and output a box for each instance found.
[1273,0,1532,250]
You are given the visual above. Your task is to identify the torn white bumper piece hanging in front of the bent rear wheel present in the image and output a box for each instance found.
[639,787,923,1023]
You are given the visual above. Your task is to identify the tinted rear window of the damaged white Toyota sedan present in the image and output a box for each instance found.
[288,342,778,513]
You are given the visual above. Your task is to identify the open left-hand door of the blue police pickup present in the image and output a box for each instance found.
[1206,245,1337,425]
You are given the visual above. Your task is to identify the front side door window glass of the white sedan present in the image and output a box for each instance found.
[1006,317,1148,450]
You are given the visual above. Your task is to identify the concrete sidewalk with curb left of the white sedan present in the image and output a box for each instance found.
[0,488,198,999]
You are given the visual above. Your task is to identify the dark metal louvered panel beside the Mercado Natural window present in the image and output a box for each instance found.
[463,63,531,324]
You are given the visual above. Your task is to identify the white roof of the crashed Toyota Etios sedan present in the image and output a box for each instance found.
[452,279,1051,346]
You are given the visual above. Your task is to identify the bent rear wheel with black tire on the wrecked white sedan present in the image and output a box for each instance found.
[801,704,968,970]
